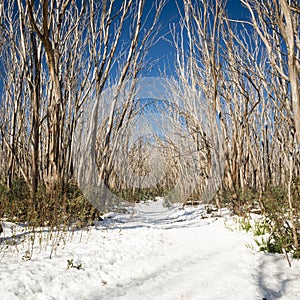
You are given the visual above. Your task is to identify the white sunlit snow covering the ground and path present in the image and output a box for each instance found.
[0,199,300,300]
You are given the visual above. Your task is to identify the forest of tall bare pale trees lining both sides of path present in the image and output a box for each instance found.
[0,0,300,257]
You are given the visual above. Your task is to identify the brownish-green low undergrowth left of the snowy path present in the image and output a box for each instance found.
[0,179,101,260]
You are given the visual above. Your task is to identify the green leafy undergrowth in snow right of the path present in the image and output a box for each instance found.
[221,184,300,259]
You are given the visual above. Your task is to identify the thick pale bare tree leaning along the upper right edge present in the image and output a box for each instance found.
[242,0,300,141]
